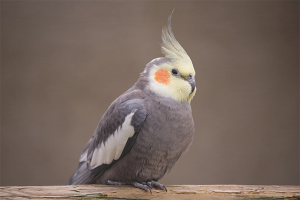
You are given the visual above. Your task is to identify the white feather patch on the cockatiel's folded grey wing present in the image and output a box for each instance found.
[79,110,136,168]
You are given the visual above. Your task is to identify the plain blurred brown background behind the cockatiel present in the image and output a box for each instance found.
[1,1,300,185]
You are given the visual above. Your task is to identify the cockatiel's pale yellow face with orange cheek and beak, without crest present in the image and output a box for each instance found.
[150,62,196,102]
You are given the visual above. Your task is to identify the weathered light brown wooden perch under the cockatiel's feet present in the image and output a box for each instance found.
[0,185,300,200]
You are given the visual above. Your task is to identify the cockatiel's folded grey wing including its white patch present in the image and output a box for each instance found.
[67,99,146,185]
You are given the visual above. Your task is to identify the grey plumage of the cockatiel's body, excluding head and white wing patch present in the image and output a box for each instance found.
[68,58,194,184]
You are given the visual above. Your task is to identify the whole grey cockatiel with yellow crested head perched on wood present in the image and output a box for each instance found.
[68,15,196,192]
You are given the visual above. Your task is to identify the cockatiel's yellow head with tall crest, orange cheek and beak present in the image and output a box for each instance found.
[146,15,196,102]
